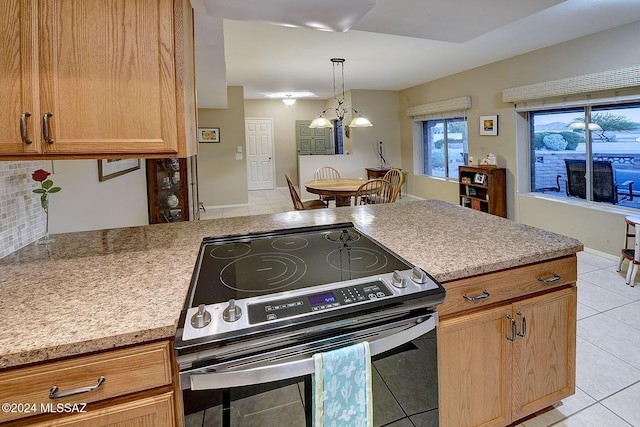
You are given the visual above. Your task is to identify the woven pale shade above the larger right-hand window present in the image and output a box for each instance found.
[502,65,640,102]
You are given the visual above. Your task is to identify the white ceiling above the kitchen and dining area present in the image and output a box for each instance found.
[191,0,640,108]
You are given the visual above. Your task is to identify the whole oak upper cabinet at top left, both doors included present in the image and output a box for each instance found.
[0,0,197,160]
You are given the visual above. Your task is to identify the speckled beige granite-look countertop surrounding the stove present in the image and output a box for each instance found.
[0,200,582,369]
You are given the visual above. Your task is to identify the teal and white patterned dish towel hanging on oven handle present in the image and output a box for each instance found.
[313,342,373,427]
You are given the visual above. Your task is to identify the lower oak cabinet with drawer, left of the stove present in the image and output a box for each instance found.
[0,340,183,427]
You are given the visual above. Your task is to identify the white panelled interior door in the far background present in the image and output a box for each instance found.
[245,119,274,190]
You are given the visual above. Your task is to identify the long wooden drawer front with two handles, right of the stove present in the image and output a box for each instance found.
[438,255,578,317]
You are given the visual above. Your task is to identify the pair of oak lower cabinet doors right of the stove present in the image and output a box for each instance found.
[438,286,577,427]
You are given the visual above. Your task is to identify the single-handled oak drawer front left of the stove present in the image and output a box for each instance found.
[0,341,171,422]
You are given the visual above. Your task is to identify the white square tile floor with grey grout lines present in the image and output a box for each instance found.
[195,192,640,427]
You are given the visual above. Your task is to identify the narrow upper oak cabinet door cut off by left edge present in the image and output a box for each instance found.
[0,0,41,154]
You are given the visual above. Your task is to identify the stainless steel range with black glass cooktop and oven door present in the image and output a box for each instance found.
[175,223,445,427]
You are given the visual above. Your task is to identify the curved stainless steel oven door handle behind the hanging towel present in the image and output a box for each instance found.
[181,313,438,390]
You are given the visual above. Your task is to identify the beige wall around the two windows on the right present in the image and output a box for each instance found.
[400,22,640,255]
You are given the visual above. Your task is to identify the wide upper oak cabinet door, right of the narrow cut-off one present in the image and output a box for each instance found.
[37,0,178,155]
